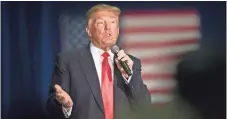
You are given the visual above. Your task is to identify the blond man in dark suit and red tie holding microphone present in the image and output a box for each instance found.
[47,4,150,119]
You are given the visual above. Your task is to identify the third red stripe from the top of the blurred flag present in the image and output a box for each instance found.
[123,38,198,49]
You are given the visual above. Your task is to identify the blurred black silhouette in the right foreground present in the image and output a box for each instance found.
[177,42,226,119]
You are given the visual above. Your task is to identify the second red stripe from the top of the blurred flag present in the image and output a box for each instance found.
[122,26,200,34]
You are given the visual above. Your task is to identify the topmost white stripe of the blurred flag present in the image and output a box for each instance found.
[122,15,199,28]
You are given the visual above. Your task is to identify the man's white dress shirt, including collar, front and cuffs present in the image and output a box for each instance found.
[62,43,131,118]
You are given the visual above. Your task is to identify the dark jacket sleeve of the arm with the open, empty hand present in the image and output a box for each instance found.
[46,54,70,119]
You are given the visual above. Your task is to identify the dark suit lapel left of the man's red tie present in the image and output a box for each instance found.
[79,45,104,111]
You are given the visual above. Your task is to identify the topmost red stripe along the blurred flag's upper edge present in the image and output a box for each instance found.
[122,9,197,17]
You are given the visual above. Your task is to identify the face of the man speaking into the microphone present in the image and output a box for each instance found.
[86,10,119,51]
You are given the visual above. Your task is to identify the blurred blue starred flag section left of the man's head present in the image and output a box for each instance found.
[59,13,89,51]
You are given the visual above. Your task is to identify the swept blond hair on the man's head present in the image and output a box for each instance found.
[86,4,121,25]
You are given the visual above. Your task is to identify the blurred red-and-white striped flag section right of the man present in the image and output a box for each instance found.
[121,9,201,104]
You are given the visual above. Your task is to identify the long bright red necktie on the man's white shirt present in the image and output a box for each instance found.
[102,52,114,119]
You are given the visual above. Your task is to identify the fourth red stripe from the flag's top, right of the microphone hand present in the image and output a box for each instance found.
[141,53,185,64]
